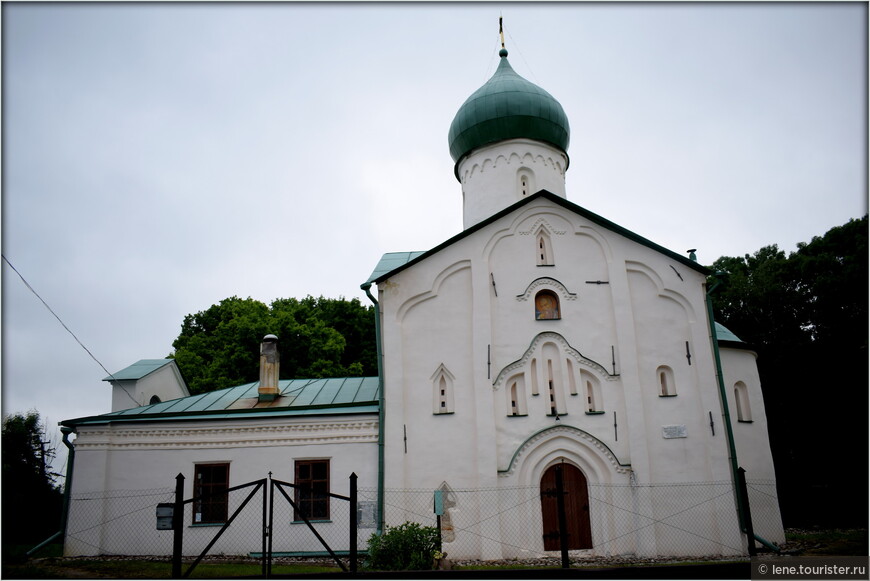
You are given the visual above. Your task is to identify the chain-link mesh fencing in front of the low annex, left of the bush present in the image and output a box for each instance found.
[64,481,374,557]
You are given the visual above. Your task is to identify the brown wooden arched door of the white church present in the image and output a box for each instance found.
[541,462,592,551]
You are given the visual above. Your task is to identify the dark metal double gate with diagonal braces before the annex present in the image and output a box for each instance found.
[171,472,357,579]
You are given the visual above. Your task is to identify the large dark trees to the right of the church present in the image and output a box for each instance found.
[712,216,868,526]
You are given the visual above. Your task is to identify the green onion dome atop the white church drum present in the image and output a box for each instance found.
[447,49,571,169]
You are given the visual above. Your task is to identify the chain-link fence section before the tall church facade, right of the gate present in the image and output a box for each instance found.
[360,481,784,560]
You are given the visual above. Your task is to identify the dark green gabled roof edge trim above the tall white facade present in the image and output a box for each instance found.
[366,190,713,284]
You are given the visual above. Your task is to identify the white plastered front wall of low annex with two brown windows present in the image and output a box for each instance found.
[64,414,377,556]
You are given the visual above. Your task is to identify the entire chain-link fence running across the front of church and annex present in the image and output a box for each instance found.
[65,480,784,560]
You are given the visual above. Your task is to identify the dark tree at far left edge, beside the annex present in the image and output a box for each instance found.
[2,411,63,544]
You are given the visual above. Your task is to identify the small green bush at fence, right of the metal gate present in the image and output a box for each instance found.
[366,522,438,571]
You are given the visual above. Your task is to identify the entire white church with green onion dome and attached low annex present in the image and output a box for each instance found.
[63,43,784,559]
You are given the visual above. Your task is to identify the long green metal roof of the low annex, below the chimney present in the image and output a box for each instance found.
[61,377,378,426]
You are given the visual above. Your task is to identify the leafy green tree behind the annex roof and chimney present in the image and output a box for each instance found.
[170,296,377,394]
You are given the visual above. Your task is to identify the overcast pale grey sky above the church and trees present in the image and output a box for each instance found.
[2,2,868,464]
